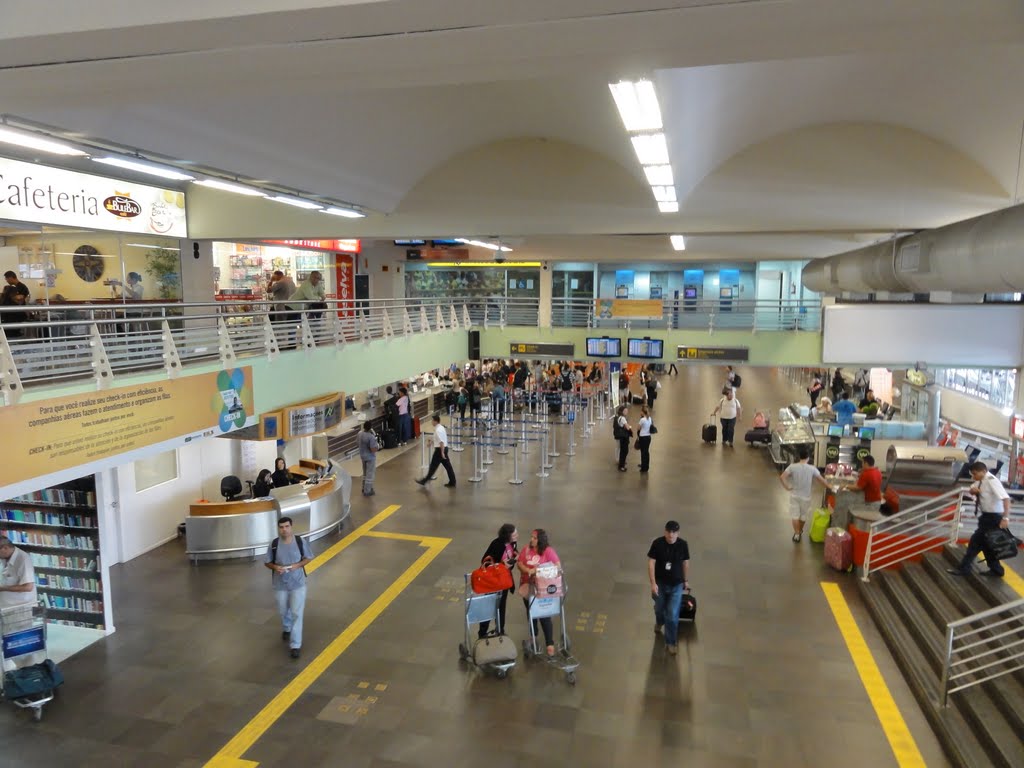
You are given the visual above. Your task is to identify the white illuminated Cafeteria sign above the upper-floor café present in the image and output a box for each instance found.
[0,158,188,238]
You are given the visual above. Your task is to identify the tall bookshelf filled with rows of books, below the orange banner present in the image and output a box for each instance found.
[0,476,105,630]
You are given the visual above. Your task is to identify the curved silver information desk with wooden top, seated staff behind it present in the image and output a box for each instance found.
[185,460,352,562]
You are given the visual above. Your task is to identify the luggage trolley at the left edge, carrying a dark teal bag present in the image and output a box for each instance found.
[0,603,59,721]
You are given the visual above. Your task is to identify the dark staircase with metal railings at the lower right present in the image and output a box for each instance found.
[860,545,1024,768]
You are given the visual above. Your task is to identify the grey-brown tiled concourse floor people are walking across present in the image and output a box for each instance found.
[0,367,958,768]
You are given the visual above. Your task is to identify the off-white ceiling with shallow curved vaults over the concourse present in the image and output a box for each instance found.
[0,0,1024,260]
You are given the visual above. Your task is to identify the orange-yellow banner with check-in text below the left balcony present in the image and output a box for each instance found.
[0,368,255,486]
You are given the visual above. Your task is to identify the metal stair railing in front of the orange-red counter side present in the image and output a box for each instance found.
[860,487,974,582]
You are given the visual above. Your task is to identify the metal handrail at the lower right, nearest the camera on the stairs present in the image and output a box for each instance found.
[940,599,1024,707]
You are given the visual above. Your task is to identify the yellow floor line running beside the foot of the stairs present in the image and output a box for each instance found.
[821,582,925,768]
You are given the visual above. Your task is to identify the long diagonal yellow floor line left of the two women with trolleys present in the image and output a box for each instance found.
[206,538,452,768]
